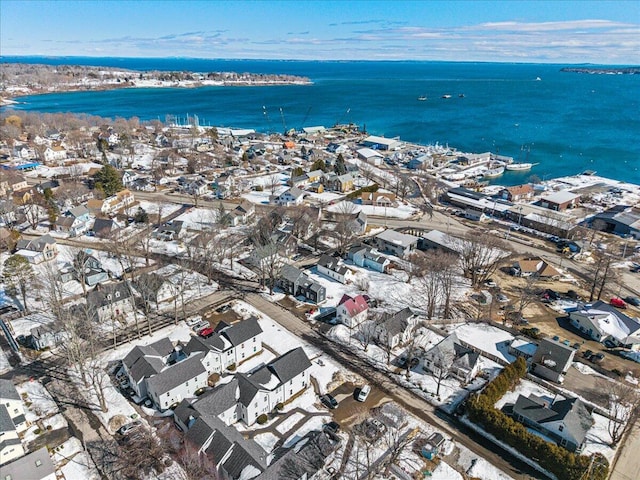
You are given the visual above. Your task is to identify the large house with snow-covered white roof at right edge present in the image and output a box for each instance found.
[569,300,640,351]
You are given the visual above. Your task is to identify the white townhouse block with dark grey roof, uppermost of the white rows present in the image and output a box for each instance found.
[182,317,262,374]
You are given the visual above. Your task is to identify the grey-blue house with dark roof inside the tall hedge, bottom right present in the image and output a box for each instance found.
[512,394,594,452]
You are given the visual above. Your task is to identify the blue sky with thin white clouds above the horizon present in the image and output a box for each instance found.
[0,0,640,64]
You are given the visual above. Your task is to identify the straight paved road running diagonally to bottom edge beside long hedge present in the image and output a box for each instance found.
[245,293,545,480]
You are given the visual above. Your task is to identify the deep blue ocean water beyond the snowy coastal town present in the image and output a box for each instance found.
[0,57,640,184]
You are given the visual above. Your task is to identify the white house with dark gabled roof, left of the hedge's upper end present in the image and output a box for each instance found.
[422,333,480,383]
